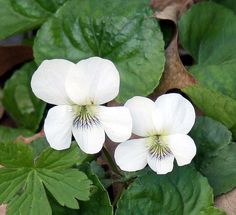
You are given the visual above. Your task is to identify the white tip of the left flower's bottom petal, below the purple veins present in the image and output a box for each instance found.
[72,124,105,154]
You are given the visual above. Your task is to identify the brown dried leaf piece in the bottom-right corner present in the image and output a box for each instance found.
[215,188,236,215]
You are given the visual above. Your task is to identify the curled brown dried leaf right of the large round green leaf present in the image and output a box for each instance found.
[150,0,200,99]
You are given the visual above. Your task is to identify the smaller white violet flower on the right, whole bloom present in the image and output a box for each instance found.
[115,93,196,174]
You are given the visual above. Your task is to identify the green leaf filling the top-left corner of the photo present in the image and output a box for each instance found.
[0,0,66,39]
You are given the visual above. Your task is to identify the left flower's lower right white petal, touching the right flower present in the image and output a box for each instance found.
[97,106,132,142]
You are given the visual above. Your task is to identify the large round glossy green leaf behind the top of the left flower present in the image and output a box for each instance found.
[34,0,164,102]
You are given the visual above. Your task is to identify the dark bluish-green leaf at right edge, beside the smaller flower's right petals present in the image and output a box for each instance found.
[190,117,236,195]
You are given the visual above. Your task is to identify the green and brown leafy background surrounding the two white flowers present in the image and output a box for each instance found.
[0,0,236,215]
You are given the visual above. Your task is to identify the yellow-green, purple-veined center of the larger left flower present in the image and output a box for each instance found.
[73,105,100,129]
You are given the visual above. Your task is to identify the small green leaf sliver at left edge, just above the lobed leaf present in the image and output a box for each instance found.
[0,126,32,143]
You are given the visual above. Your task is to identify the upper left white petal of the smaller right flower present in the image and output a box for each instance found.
[125,96,156,137]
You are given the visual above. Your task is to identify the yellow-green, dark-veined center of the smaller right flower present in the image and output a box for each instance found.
[147,135,172,160]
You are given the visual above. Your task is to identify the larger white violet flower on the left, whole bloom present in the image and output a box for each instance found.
[31,57,132,154]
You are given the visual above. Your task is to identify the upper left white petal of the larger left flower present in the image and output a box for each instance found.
[31,59,75,105]
